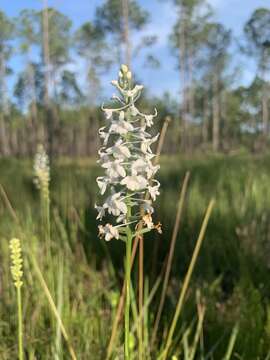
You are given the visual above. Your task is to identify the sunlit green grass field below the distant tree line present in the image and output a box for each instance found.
[0,155,270,360]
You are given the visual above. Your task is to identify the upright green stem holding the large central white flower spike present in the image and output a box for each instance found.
[125,207,132,360]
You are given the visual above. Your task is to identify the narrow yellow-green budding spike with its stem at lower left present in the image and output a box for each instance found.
[10,239,23,360]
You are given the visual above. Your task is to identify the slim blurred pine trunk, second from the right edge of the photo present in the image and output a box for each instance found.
[212,71,220,151]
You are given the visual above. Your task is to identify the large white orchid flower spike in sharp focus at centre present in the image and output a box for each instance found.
[95,65,160,241]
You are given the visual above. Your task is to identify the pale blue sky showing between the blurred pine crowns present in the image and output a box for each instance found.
[0,0,270,100]
